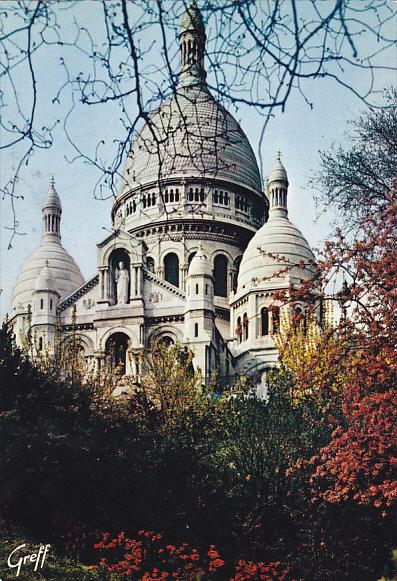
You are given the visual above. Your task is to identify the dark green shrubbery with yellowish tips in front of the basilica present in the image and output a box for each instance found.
[0,320,392,581]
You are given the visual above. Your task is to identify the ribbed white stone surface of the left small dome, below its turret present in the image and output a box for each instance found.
[12,240,84,309]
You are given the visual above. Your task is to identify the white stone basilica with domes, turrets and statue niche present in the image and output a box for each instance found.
[9,1,314,385]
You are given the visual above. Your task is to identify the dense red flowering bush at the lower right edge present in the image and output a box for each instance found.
[311,390,397,510]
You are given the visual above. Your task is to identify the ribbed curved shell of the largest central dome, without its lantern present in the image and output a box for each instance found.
[124,83,261,192]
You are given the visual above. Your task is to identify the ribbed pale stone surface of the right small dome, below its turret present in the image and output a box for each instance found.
[238,210,315,291]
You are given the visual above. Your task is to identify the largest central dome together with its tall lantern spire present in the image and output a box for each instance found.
[121,0,262,196]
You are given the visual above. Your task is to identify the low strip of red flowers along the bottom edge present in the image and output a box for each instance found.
[94,530,293,581]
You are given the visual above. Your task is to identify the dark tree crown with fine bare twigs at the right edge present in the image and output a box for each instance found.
[313,87,397,227]
